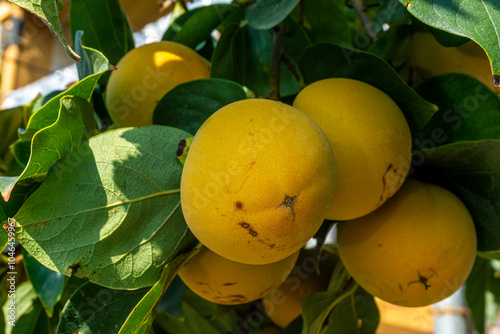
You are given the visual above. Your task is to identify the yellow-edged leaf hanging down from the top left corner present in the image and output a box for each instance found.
[10,0,80,61]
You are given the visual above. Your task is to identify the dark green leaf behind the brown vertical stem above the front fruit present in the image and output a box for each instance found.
[210,24,300,97]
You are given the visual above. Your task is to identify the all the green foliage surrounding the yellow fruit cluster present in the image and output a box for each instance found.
[0,0,500,334]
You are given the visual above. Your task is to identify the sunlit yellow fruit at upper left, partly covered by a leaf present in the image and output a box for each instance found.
[106,41,210,127]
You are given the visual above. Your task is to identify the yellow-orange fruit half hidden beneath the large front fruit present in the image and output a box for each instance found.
[179,247,299,305]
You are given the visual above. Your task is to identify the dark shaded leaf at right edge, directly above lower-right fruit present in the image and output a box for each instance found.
[414,139,500,252]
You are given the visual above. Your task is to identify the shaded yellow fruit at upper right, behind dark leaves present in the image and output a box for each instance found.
[410,31,500,94]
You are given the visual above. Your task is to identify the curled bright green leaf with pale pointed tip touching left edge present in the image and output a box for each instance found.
[0,96,94,201]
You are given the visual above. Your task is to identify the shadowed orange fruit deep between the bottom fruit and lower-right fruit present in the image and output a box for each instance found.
[262,245,338,328]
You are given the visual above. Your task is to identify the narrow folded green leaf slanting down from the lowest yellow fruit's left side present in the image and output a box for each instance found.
[120,244,201,334]
